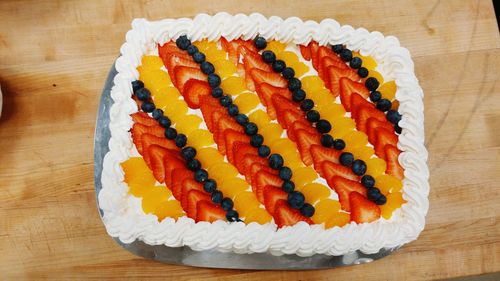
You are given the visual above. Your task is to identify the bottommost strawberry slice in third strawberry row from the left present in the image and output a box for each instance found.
[349,192,380,223]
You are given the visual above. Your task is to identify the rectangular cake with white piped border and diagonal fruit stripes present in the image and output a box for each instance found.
[98,13,429,256]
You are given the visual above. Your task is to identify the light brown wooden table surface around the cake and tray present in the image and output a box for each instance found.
[0,0,500,280]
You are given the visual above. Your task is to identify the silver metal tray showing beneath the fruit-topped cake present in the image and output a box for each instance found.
[94,61,401,270]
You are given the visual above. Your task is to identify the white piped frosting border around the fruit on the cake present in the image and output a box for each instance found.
[98,13,429,256]
